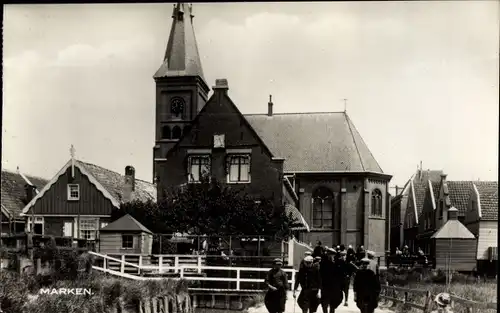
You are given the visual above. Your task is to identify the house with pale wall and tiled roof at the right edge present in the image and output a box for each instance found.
[464,182,498,272]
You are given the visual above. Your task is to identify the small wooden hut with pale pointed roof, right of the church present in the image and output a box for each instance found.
[431,207,477,272]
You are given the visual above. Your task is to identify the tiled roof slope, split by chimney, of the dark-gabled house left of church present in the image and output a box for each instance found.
[77,161,156,202]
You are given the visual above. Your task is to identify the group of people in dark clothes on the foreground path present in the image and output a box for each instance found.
[264,242,381,313]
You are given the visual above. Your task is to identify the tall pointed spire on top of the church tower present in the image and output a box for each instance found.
[154,2,205,81]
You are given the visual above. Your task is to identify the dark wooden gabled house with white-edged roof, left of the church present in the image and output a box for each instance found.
[22,157,156,240]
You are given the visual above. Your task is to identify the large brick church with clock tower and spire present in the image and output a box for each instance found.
[153,3,391,256]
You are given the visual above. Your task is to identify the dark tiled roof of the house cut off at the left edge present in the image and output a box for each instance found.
[1,171,48,218]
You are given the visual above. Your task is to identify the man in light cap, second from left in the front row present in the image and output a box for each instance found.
[293,256,321,313]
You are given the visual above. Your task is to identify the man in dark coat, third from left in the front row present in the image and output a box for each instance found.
[320,249,343,313]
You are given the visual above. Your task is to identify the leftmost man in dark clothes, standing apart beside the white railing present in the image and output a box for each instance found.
[264,259,288,313]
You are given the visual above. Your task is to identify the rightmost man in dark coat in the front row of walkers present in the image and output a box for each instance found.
[353,258,381,313]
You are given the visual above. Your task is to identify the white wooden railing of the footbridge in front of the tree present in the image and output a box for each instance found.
[89,252,296,291]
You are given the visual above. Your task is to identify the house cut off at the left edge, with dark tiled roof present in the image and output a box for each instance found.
[0,168,48,234]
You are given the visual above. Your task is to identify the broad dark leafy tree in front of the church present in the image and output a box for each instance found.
[113,179,291,239]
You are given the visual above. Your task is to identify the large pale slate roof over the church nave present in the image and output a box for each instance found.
[244,112,383,173]
